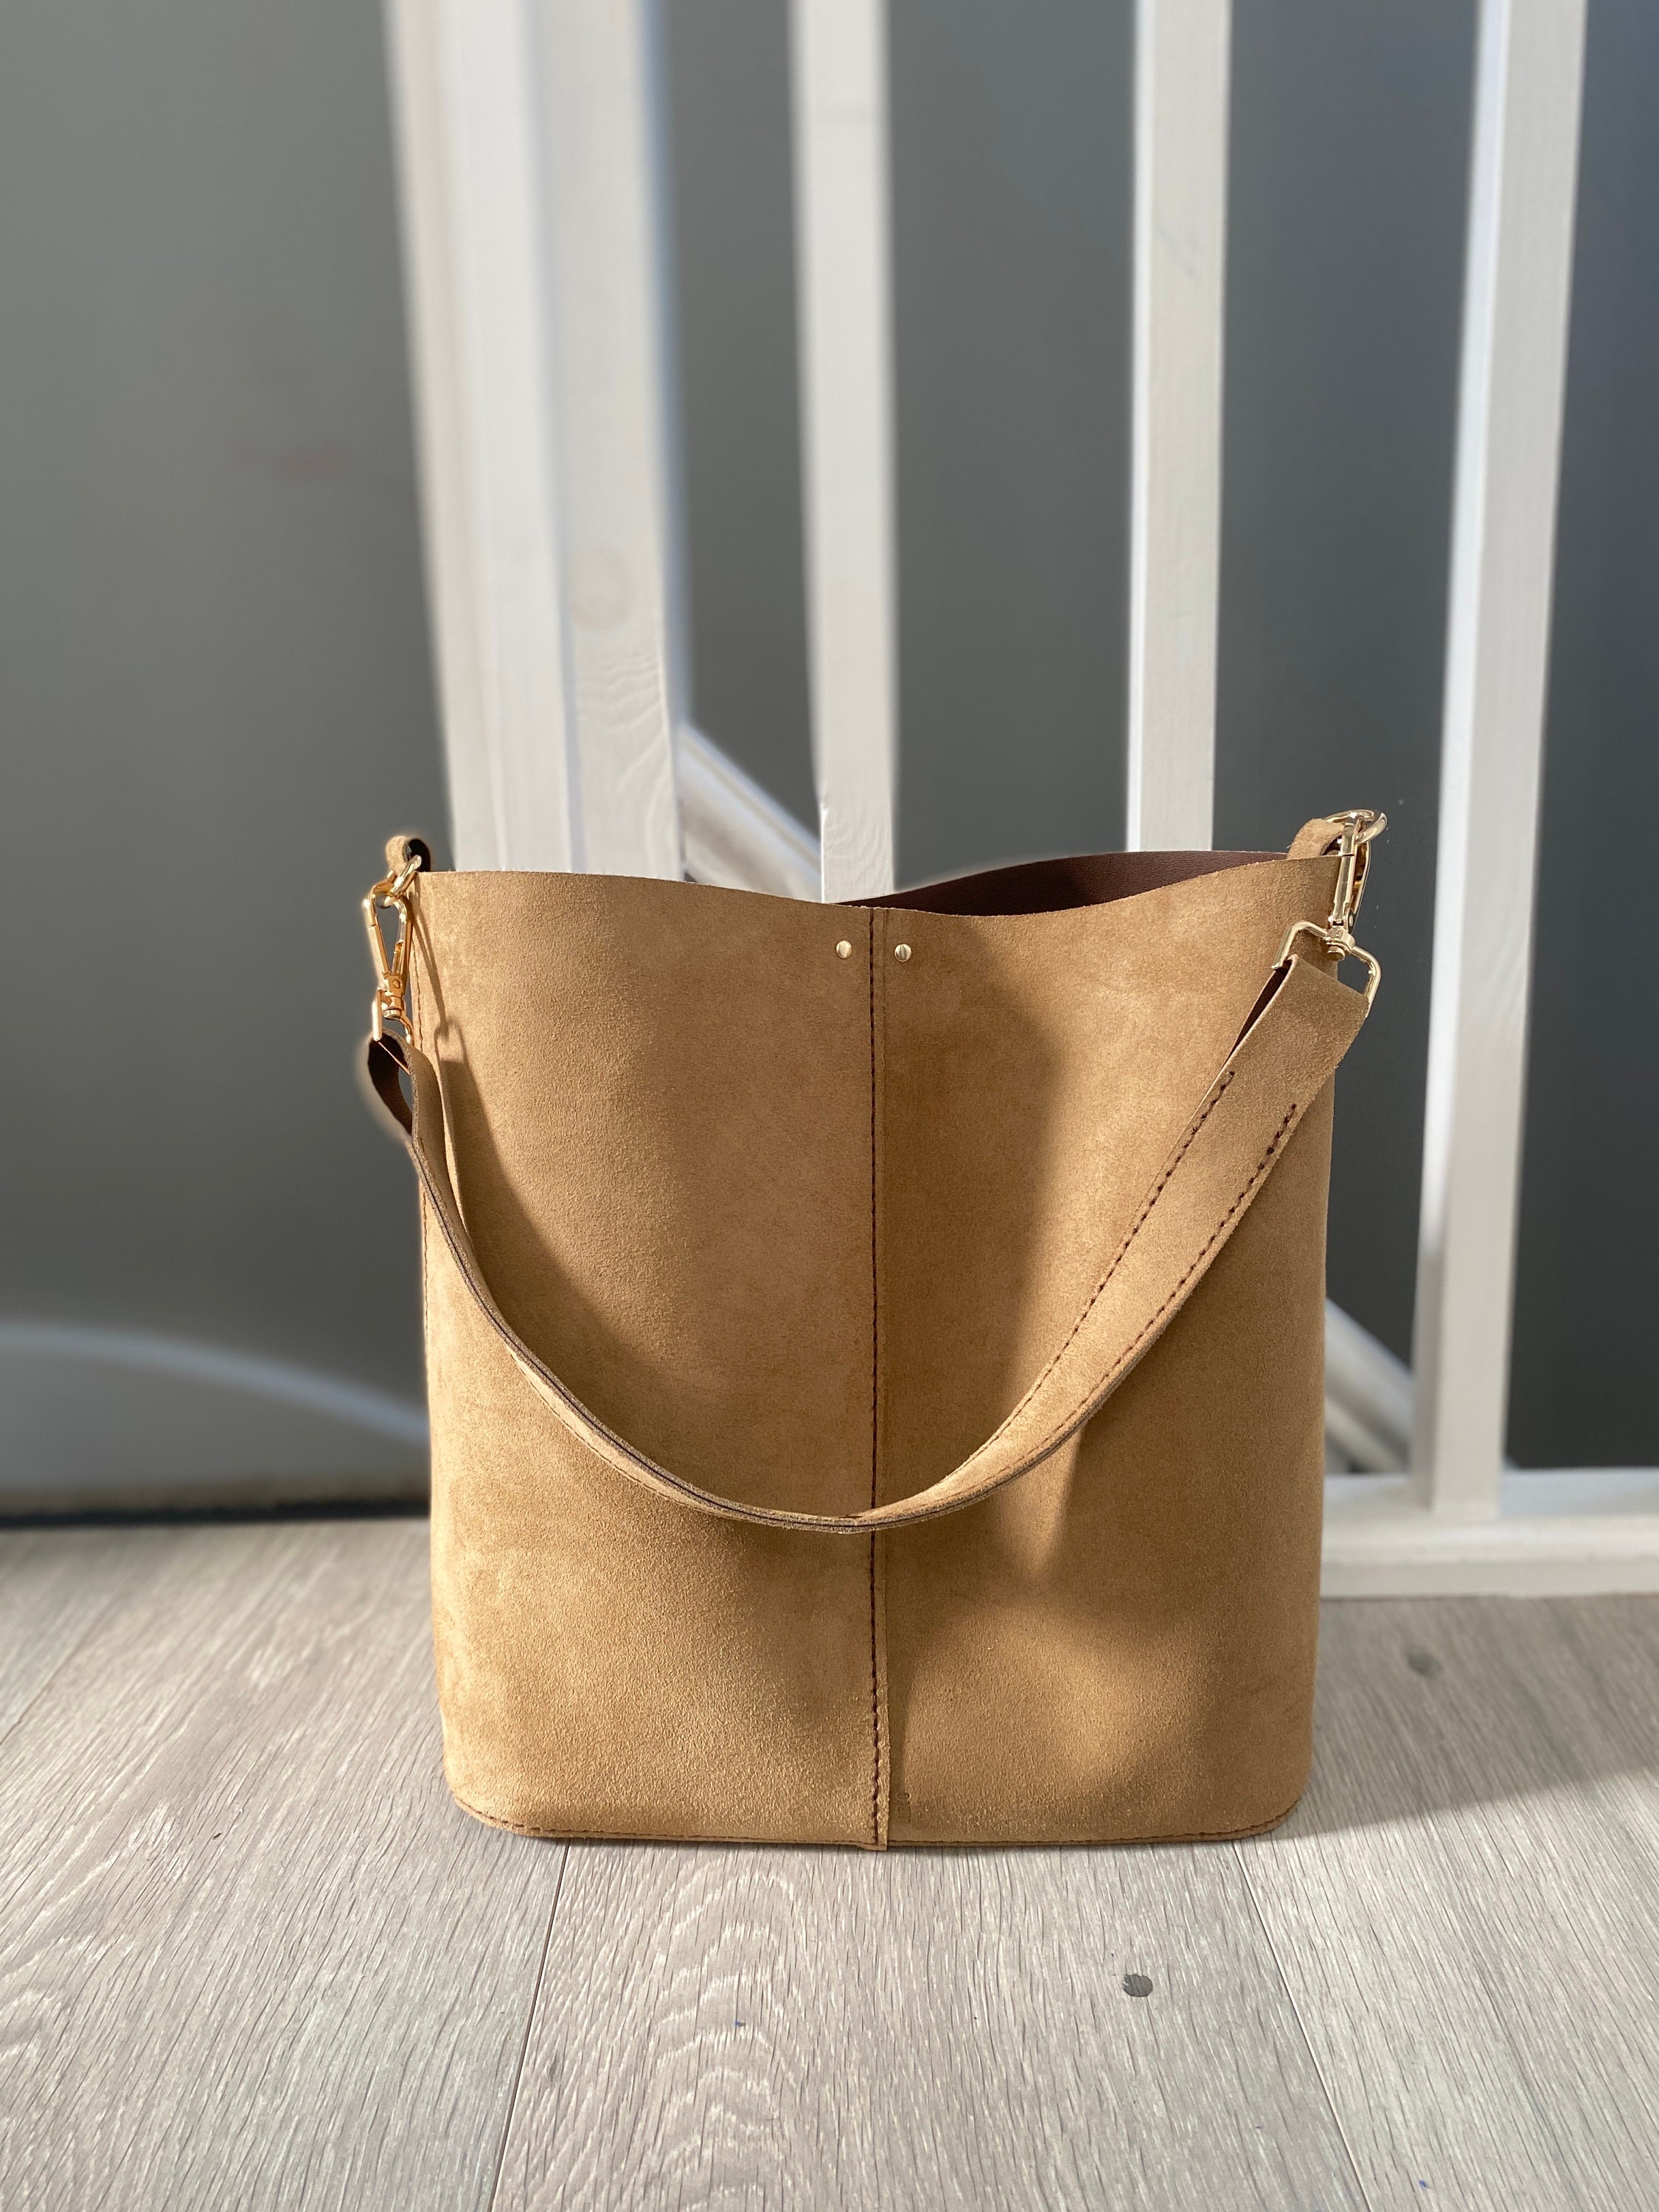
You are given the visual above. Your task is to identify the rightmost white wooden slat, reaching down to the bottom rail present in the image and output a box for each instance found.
[1411,0,1584,1520]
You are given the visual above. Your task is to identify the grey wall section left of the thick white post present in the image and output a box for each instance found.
[0,0,445,1394]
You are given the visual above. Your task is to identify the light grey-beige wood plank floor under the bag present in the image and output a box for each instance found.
[0,1522,1659,2212]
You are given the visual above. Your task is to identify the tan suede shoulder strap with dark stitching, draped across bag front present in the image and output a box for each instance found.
[369,956,1367,1533]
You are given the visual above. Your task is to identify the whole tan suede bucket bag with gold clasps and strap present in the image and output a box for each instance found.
[367,814,1380,1849]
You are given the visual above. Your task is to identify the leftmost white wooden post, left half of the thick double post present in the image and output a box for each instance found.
[387,0,580,867]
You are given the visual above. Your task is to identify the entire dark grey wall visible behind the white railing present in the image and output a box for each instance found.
[0,0,1659,1464]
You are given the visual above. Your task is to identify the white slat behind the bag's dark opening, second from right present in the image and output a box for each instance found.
[1126,0,1232,852]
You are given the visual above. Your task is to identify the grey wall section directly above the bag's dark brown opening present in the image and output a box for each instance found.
[891,0,1133,878]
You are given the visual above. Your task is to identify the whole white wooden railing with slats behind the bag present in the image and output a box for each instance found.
[387,0,1659,1590]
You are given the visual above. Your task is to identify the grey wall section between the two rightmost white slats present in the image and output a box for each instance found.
[1217,0,1473,1398]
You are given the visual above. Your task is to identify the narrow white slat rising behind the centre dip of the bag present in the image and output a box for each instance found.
[790,0,898,898]
